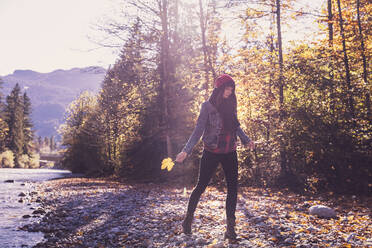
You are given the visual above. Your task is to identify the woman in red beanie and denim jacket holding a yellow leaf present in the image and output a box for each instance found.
[176,74,254,240]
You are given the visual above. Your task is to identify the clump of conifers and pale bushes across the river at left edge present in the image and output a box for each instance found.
[0,80,60,169]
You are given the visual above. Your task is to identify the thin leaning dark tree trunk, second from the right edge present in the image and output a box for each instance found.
[337,0,355,118]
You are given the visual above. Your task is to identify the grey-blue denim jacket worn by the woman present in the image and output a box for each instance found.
[182,101,251,154]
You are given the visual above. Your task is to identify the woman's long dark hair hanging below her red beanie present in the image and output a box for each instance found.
[209,82,240,131]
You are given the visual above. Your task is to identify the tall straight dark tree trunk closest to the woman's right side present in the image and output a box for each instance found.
[276,0,288,175]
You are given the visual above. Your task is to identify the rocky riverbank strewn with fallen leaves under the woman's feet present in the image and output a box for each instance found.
[22,178,372,248]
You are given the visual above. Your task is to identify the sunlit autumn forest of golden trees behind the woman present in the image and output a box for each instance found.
[60,0,372,194]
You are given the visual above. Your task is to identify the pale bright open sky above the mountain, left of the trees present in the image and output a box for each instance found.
[0,0,117,76]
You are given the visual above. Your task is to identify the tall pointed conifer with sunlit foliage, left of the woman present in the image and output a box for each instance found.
[98,19,158,172]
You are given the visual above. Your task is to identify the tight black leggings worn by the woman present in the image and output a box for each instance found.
[187,150,238,219]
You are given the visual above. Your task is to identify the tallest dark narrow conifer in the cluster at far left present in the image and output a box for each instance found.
[5,84,24,167]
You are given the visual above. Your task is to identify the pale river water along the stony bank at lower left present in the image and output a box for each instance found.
[0,168,71,248]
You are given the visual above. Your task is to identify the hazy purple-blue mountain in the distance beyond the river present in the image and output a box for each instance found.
[1,66,106,137]
